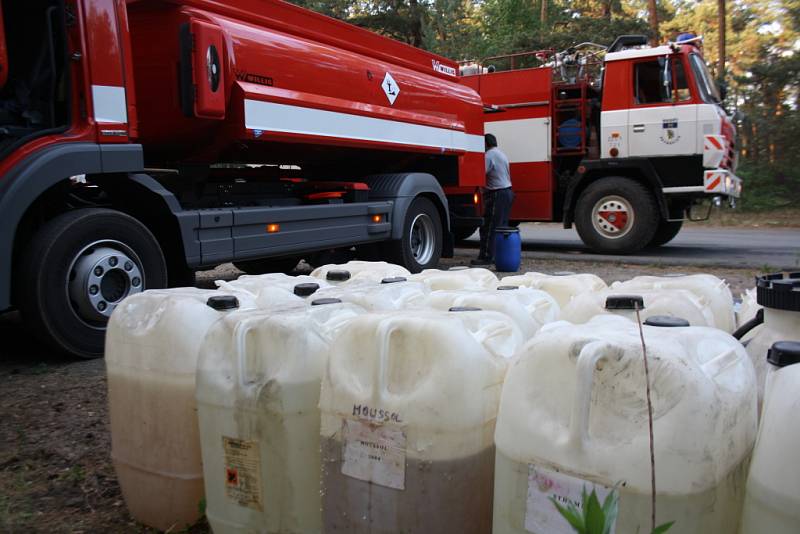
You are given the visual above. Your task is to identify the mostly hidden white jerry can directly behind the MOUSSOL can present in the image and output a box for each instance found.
[425,286,558,339]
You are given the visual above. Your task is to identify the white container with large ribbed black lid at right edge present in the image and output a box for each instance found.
[742,273,800,416]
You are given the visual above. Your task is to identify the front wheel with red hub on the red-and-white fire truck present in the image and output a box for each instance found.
[575,176,660,254]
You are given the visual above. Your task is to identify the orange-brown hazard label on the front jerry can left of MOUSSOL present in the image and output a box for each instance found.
[222,436,261,510]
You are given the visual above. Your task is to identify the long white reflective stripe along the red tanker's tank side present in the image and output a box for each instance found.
[244,99,484,153]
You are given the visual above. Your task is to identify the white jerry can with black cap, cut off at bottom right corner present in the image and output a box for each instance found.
[740,341,800,534]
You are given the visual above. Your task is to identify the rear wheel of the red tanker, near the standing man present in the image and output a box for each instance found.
[386,197,443,273]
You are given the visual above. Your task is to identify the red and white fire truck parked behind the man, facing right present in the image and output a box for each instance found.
[460,35,742,254]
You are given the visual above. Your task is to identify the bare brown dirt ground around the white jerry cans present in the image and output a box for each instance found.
[0,250,759,533]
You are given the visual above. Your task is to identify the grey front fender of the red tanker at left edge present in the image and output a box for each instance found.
[0,143,144,311]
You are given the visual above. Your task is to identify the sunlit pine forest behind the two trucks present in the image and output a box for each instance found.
[293,0,800,214]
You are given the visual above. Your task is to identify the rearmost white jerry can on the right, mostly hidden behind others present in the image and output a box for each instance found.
[611,274,736,333]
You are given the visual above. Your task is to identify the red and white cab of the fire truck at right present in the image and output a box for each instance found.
[600,36,741,199]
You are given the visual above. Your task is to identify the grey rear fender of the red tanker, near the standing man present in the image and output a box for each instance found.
[361,172,450,241]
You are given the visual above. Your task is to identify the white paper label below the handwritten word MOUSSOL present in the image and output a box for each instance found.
[342,419,406,490]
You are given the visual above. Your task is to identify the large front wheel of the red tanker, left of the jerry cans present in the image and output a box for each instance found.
[17,208,167,359]
